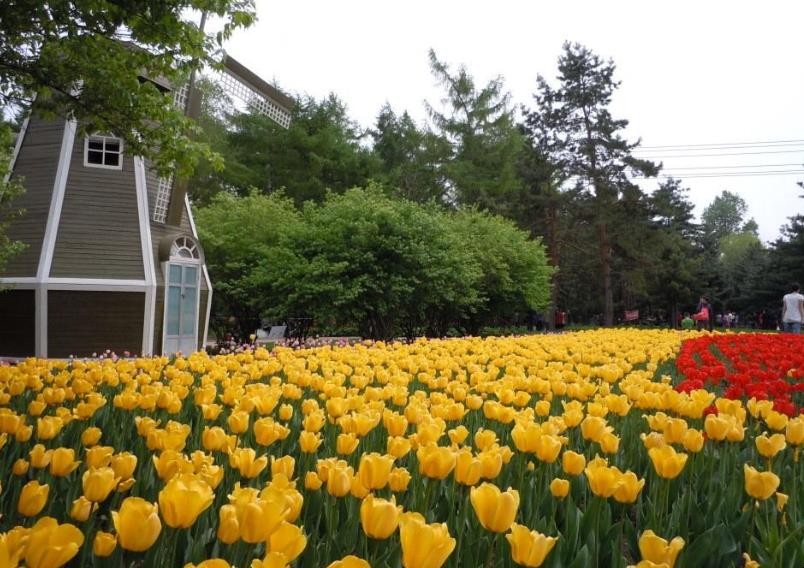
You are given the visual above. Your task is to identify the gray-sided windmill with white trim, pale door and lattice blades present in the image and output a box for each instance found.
[0,57,292,357]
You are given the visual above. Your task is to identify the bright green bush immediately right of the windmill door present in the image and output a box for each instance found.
[195,192,301,338]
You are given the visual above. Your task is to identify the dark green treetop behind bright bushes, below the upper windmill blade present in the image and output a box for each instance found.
[195,95,384,205]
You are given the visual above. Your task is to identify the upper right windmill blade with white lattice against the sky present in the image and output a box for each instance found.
[217,55,293,128]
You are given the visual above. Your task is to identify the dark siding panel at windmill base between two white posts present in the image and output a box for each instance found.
[47,290,145,357]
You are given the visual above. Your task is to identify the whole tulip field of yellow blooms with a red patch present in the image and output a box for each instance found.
[0,329,804,568]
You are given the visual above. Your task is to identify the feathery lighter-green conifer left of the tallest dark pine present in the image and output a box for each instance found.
[427,49,522,213]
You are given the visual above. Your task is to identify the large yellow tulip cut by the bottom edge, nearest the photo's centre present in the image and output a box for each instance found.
[399,513,455,568]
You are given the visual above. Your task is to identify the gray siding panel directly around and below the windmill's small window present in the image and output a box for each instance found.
[50,131,145,279]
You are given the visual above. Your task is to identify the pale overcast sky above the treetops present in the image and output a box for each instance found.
[220,0,804,241]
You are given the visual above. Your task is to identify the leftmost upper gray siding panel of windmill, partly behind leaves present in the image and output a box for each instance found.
[3,117,64,277]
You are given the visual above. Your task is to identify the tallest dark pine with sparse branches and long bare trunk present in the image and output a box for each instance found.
[527,43,657,325]
